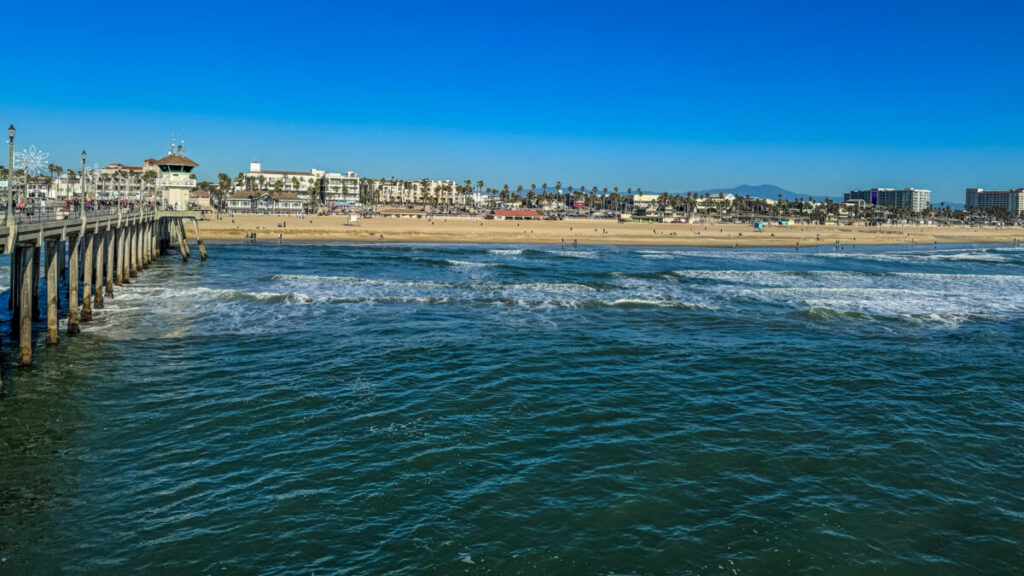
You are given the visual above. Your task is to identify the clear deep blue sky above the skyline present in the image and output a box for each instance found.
[0,0,1024,202]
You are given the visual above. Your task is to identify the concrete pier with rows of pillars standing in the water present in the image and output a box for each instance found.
[0,207,206,393]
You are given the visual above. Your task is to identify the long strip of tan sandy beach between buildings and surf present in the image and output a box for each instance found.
[200,214,1024,247]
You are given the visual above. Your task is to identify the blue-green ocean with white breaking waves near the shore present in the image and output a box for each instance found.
[0,239,1024,575]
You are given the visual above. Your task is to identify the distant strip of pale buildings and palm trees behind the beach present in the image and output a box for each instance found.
[0,141,1024,223]
